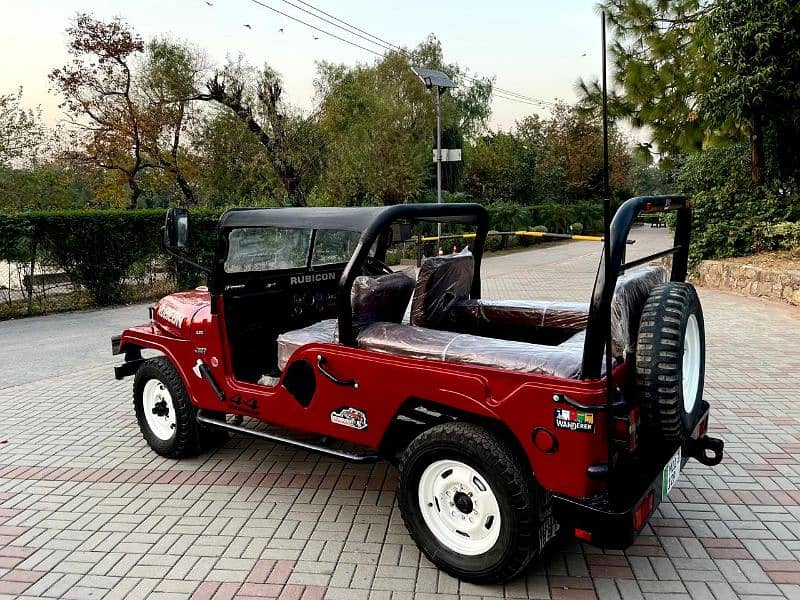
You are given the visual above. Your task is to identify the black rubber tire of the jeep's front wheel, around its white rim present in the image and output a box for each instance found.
[133,356,227,458]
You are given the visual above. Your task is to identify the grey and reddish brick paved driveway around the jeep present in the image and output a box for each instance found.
[0,229,800,600]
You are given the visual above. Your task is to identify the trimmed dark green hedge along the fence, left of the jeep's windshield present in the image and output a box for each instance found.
[0,210,219,306]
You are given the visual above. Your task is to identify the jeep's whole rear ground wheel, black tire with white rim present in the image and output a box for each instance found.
[399,423,555,583]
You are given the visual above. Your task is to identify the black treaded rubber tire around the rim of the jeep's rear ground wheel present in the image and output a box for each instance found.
[398,422,545,583]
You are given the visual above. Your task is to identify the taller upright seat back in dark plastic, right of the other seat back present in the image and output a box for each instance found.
[411,248,475,329]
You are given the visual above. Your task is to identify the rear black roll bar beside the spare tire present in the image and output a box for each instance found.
[581,195,692,379]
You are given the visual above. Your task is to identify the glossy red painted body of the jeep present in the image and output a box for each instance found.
[121,291,624,498]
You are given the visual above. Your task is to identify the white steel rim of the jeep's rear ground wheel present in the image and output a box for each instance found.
[419,460,501,556]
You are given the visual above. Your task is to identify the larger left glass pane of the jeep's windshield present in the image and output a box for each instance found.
[225,227,311,273]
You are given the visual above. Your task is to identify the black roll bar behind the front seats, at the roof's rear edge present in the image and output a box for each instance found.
[336,203,489,346]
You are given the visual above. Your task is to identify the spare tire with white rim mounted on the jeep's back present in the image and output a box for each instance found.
[636,281,706,443]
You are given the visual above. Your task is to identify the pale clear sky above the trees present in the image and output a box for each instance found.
[0,0,612,129]
